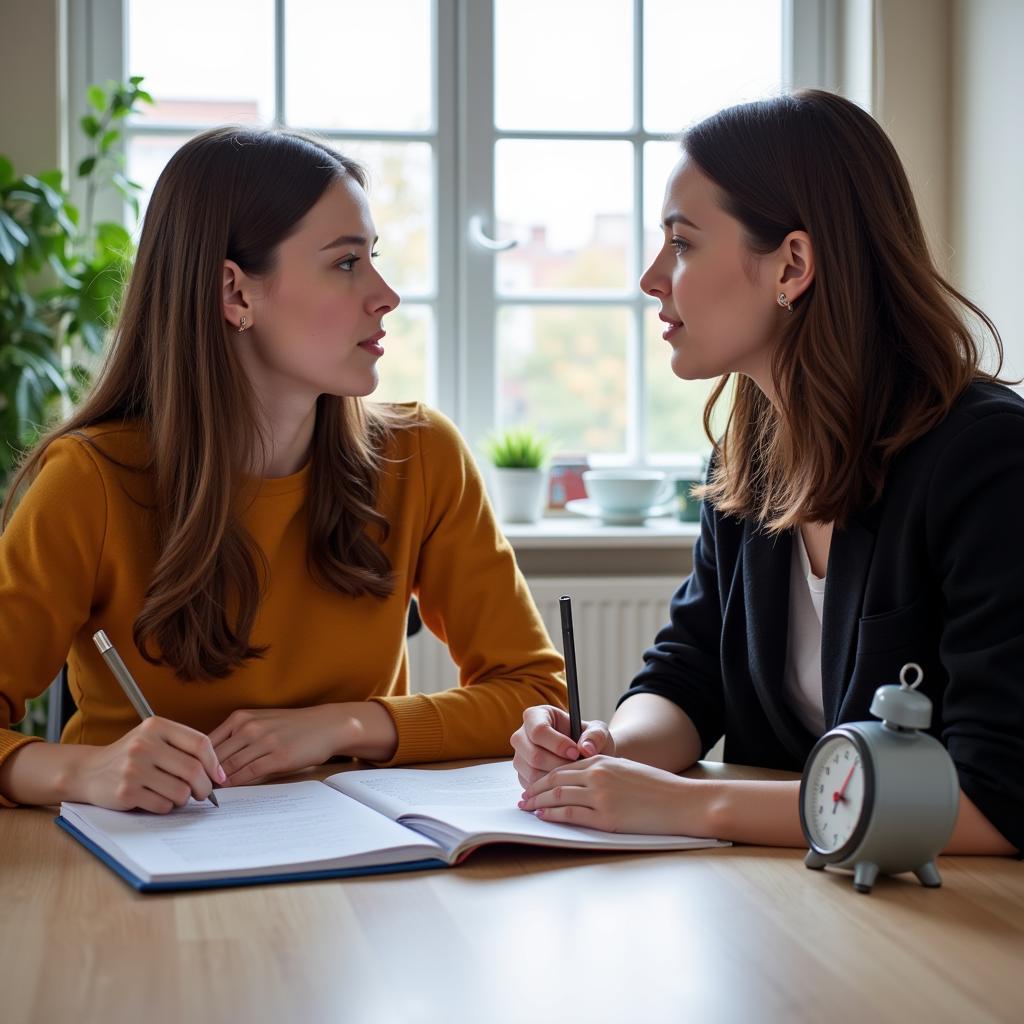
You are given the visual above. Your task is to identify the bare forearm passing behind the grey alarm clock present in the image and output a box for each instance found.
[688,779,1016,856]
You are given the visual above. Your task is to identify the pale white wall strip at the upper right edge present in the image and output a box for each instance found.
[949,0,1024,377]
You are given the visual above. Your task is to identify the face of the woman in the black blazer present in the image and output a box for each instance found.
[640,154,790,387]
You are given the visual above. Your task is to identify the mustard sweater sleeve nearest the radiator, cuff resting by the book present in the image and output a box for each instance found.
[374,411,566,765]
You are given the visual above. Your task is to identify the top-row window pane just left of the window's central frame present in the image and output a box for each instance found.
[285,0,434,131]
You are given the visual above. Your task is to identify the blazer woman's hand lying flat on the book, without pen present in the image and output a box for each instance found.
[516,755,707,836]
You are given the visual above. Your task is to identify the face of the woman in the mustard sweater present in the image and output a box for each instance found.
[232,175,399,401]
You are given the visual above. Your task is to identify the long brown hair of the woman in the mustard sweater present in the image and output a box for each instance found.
[4,127,400,680]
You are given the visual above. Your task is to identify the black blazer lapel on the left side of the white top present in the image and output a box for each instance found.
[743,523,808,761]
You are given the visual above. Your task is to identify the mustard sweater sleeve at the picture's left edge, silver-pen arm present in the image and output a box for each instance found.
[0,437,106,806]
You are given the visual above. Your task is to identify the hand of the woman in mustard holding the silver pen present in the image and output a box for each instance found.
[74,717,225,814]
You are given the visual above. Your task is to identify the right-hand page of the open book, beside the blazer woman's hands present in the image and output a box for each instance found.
[327,761,718,850]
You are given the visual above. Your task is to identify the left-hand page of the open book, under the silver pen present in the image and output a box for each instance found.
[61,781,441,880]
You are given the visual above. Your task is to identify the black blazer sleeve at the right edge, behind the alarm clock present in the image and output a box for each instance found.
[927,413,1024,850]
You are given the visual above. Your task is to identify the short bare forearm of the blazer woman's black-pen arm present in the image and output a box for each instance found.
[608,693,700,772]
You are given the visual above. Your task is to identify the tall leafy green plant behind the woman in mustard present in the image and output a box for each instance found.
[0,76,153,497]
